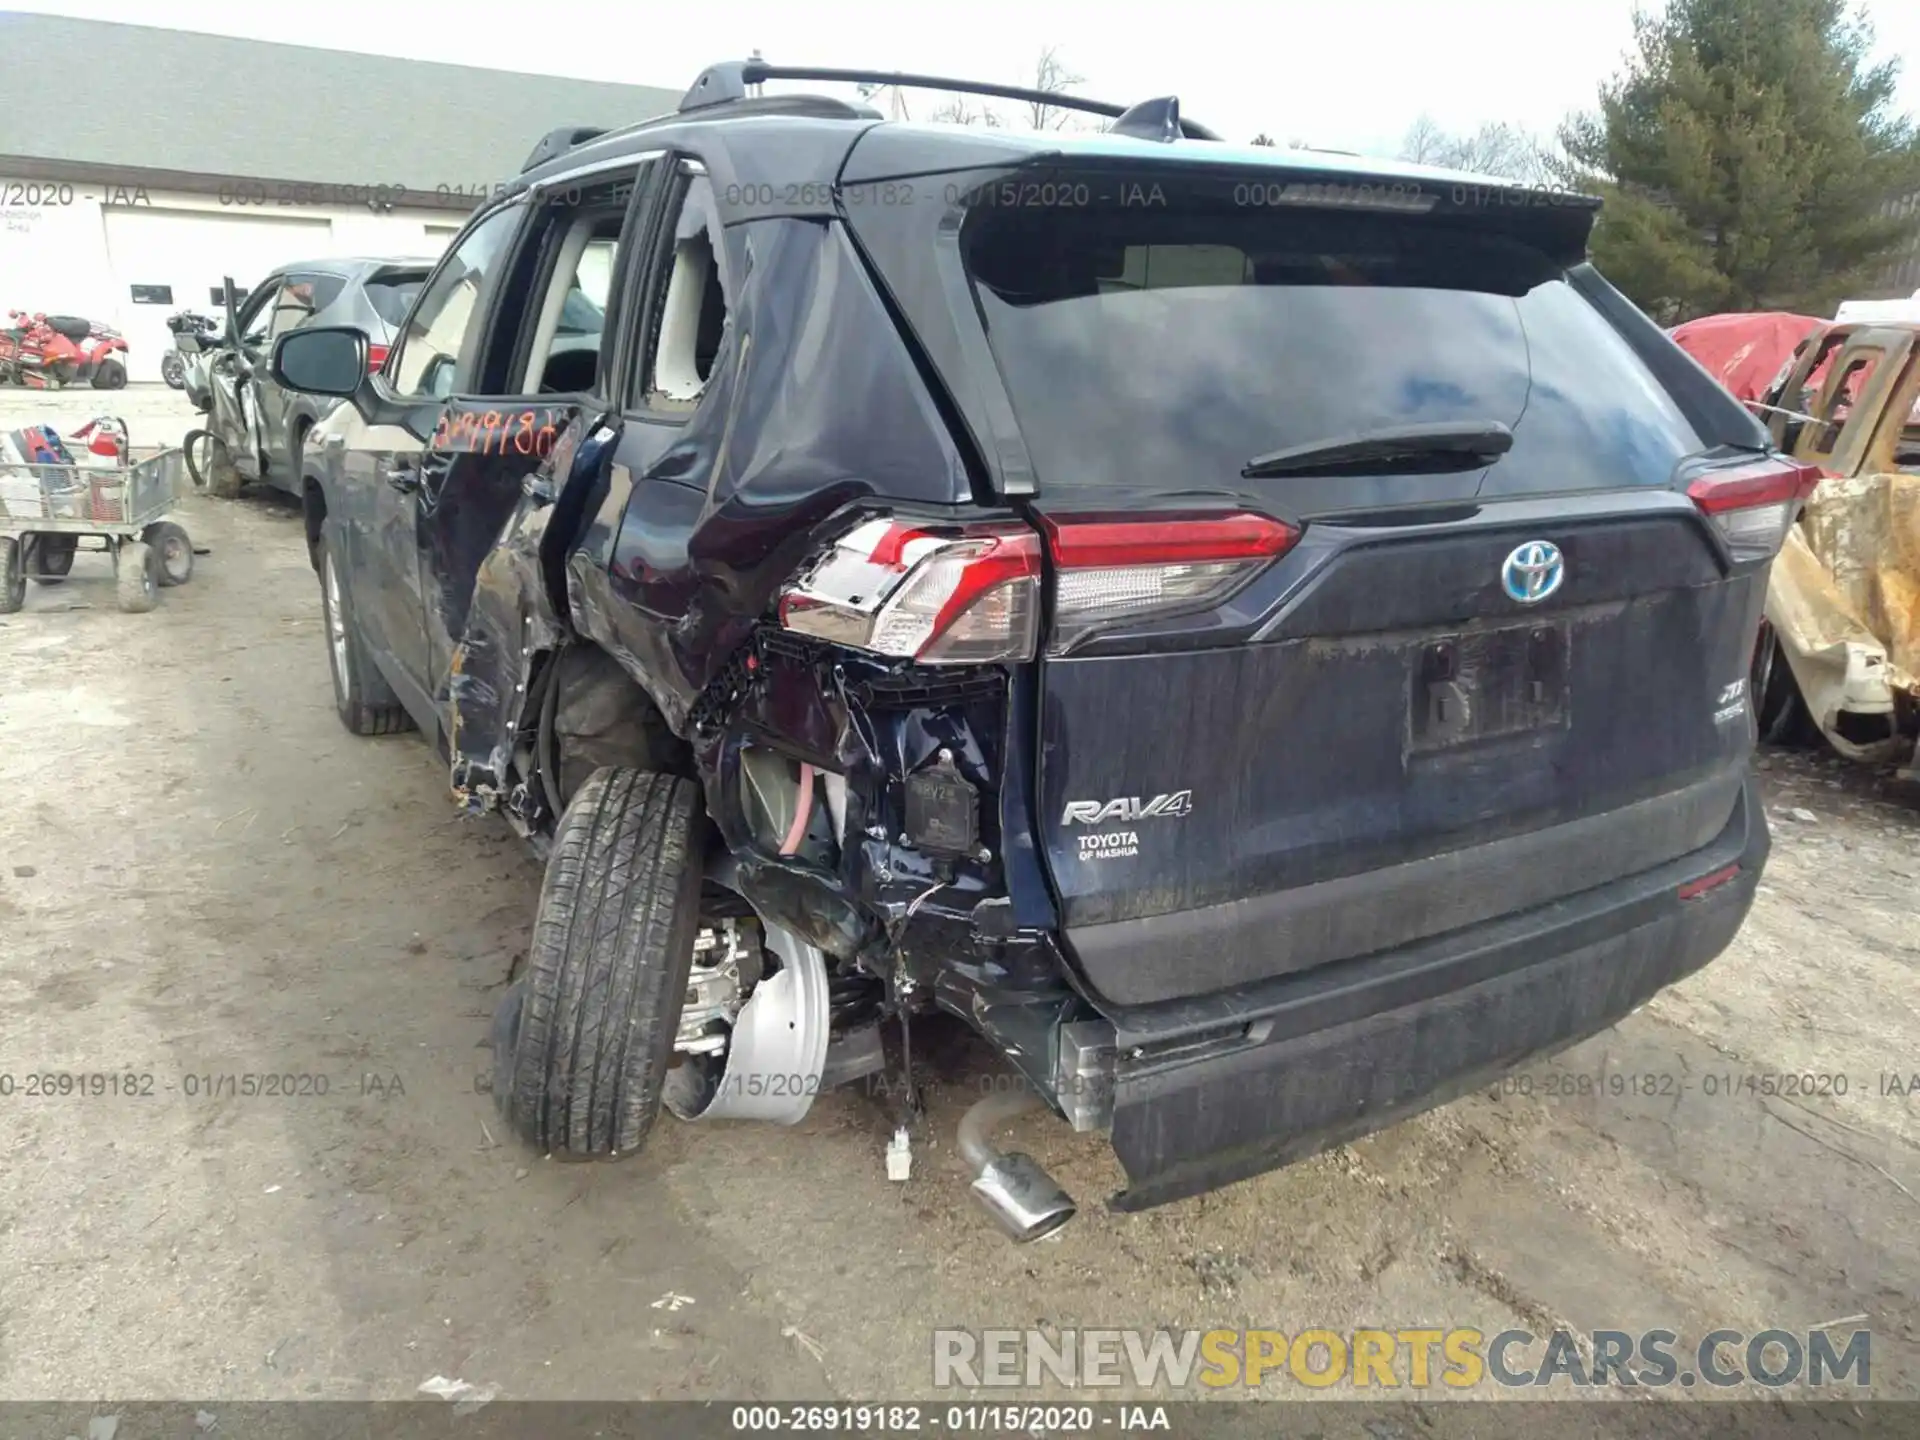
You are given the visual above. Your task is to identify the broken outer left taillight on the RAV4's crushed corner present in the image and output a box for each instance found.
[780,520,1041,664]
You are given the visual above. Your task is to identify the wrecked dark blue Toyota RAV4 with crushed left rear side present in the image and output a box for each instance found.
[273,61,1812,1238]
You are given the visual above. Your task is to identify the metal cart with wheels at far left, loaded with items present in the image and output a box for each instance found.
[0,449,194,614]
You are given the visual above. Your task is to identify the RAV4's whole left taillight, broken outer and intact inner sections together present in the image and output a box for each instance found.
[780,513,1300,664]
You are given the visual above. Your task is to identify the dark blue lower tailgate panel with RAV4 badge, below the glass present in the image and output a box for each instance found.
[1039,493,1761,1004]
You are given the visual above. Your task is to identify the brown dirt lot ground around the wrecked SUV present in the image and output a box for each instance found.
[0,392,1920,1400]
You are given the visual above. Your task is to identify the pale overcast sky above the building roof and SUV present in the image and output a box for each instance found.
[8,0,1920,154]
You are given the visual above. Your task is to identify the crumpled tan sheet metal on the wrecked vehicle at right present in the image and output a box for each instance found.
[1766,472,1920,760]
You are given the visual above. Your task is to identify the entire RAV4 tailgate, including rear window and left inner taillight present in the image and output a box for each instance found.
[852,157,1764,1006]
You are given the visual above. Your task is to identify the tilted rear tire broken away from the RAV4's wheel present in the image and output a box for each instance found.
[493,768,705,1160]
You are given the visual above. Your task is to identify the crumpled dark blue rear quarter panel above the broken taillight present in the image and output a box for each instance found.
[568,219,973,735]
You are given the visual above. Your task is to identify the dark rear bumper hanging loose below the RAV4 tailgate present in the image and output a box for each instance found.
[1108,780,1768,1210]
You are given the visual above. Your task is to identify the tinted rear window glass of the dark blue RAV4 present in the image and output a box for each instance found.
[962,207,1703,493]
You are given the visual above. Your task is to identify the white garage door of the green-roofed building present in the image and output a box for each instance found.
[106,207,332,380]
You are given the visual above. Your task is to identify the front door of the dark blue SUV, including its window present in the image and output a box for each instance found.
[336,202,528,733]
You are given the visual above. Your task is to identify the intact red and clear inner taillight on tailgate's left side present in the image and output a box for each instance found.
[1041,513,1300,655]
